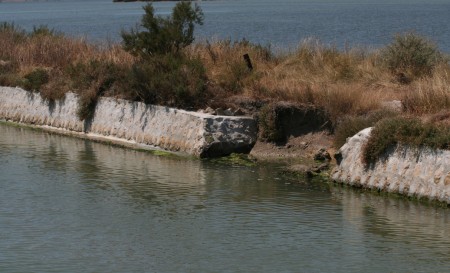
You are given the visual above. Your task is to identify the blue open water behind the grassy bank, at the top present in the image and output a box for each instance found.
[0,0,450,53]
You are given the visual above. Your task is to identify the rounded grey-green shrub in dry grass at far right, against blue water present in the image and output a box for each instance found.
[383,33,443,83]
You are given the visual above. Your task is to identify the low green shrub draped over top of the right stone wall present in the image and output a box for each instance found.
[363,117,450,164]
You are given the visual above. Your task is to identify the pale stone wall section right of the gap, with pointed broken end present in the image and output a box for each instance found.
[332,128,450,204]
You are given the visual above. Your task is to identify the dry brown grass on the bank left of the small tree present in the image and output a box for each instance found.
[0,23,135,99]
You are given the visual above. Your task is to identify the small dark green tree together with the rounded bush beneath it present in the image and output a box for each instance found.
[122,2,208,108]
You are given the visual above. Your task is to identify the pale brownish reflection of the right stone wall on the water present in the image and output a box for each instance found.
[335,188,450,244]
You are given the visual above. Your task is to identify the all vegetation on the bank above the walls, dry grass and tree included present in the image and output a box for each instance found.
[0,2,450,155]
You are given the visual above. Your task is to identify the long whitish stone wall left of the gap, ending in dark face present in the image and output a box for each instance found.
[0,87,257,157]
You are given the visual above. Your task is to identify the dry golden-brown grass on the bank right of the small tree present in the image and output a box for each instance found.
[190,37,450,116]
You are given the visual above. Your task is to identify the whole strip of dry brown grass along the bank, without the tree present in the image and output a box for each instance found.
[0,24,450,149]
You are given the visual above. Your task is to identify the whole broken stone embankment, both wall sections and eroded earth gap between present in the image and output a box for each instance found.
[0,87,450,204]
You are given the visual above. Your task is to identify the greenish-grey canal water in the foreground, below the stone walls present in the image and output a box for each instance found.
[0,123,450,273]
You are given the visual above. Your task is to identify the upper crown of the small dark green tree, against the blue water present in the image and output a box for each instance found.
[122,2,203,57]
